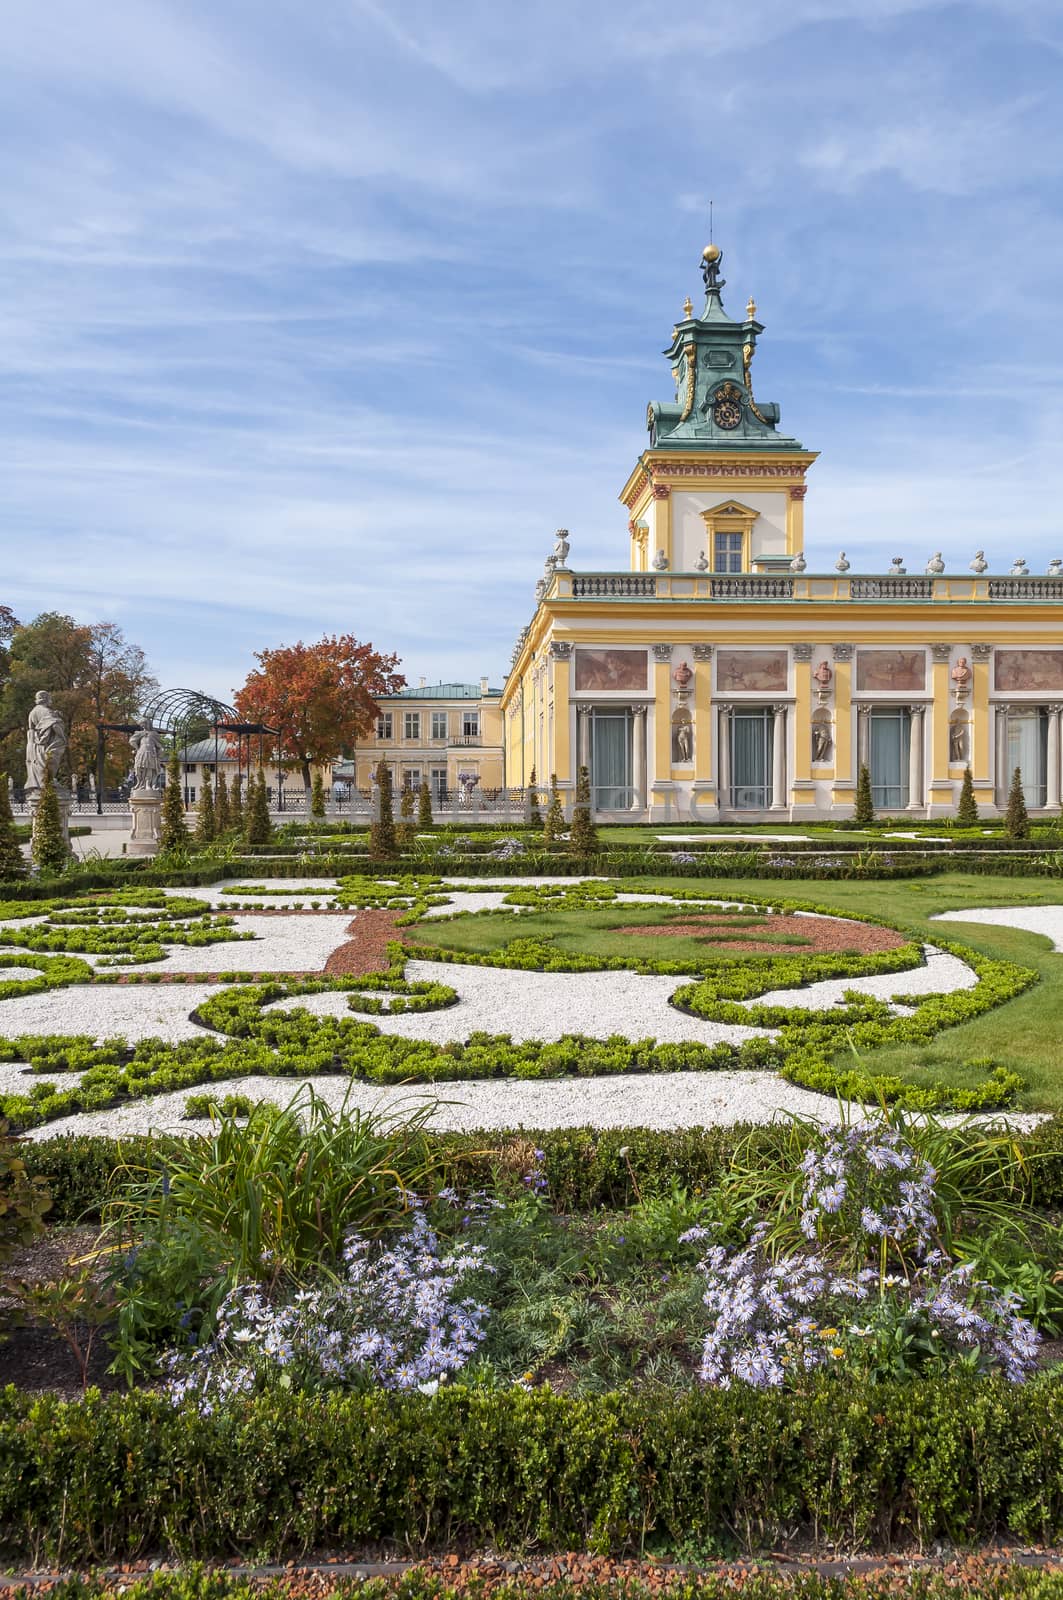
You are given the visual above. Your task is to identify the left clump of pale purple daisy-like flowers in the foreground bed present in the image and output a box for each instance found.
[166,1211,490,1414]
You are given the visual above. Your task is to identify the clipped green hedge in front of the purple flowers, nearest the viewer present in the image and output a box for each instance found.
[0,1379,1063,1563]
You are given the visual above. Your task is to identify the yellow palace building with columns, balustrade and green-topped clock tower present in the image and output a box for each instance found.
[501,245,1063,822]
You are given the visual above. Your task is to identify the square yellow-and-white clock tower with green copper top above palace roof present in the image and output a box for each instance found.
[621,245,816,573]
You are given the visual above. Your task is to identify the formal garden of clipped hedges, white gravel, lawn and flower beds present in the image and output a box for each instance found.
[0,835,1063,1562]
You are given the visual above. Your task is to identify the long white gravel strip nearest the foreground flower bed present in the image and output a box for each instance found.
[27,1072,1042,1139]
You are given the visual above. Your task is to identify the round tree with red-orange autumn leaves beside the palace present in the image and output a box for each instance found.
[235,634,407,794]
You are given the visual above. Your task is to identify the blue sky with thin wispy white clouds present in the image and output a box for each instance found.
[0,0,1063,699]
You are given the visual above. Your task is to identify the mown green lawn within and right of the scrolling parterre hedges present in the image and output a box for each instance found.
[413,872,1063,1112]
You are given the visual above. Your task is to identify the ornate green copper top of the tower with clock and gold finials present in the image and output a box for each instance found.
[647,245,804,453]
